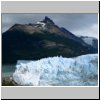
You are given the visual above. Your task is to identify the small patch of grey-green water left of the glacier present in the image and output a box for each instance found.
[2,64,16,77]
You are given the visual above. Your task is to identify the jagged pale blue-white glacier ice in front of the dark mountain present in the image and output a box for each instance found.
[13,54,98,86]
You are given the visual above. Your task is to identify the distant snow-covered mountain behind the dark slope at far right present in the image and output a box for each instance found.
[80,36,98,52]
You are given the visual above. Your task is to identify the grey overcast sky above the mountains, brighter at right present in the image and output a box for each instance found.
[2,13,98,38]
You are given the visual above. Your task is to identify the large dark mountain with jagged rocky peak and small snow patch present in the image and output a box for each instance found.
[2,16,94,64]
